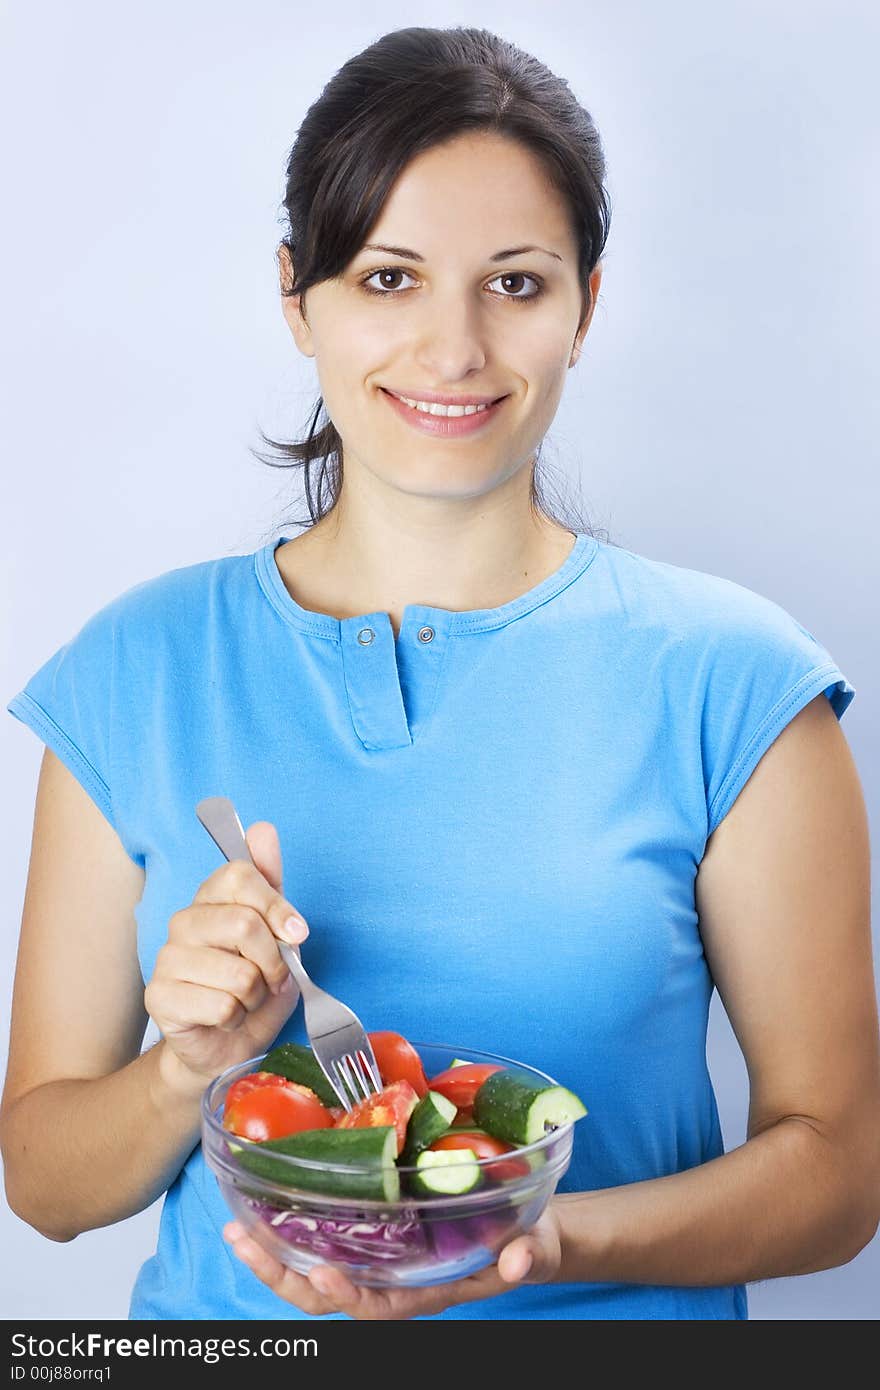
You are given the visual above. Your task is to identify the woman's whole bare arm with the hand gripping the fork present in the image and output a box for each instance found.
[0,748,307,1241]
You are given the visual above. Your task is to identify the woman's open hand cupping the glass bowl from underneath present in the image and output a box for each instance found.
[222,1205,562,1319]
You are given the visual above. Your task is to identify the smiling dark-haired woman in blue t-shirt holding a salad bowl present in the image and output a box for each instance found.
[3,29,880,1319]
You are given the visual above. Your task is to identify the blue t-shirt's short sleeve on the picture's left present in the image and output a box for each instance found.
[6,605,118,833]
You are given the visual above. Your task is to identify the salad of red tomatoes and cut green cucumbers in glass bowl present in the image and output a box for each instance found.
[222,1031,587,1200]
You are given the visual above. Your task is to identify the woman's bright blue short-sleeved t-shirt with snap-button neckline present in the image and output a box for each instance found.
[7,535,855,1319]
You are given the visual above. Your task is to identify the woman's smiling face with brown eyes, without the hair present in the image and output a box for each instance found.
[281,132,602,498]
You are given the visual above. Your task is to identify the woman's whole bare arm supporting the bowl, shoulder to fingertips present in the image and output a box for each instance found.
[227,695,880,1318]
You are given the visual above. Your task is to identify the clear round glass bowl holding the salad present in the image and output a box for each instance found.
[202,1043,574,1289]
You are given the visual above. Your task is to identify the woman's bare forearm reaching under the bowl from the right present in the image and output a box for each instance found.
[553,1118,872,1287]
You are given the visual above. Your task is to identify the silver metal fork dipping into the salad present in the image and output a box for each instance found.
[196,796,382,1111]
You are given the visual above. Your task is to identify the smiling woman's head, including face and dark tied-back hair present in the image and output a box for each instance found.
[254,28,610,534]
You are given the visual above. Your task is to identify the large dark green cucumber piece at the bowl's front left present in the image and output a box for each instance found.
[238,1125,400,1202]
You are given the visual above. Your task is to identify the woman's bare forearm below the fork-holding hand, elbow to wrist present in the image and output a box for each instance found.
[3,1043,200,1241]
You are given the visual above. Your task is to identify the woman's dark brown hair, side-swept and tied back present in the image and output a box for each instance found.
[252,26,610,535]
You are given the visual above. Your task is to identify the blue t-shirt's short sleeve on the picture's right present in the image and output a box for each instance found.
[702,591,855,838]
